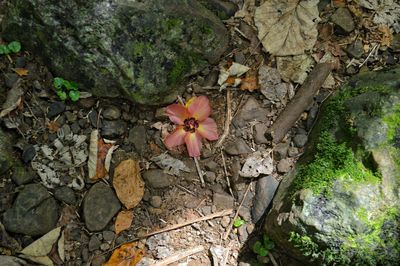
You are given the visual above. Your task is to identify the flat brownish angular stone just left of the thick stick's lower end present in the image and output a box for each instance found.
[232,96,268,128]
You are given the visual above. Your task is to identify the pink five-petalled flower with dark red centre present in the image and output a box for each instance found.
[164,96,218,157]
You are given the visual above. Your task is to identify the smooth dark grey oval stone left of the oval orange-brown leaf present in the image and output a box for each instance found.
[83,182,121,231]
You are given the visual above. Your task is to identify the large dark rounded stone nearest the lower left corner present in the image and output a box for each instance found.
[3,184,59,236]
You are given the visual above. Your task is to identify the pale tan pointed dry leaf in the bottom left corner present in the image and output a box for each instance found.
[21,227,61,266]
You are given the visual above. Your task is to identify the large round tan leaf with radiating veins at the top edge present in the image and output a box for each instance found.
[254,0,319,56]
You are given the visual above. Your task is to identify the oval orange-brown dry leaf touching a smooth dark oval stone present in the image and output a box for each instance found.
[113,159,144,209]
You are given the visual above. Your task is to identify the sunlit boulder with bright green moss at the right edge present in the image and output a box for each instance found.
[265,68,400,265]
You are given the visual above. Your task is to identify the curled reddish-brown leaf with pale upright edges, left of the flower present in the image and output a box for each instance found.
[88,130,118,180]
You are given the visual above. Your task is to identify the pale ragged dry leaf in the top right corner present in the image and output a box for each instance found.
[358,0,400,33]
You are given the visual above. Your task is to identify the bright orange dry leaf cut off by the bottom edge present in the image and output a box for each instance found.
[103,242,144,266]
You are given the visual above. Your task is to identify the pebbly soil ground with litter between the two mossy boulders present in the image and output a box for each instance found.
[0,1,400,266]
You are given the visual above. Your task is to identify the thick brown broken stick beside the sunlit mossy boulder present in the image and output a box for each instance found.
[265,63,333,143]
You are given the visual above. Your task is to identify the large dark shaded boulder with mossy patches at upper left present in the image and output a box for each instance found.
[2,0,228,105]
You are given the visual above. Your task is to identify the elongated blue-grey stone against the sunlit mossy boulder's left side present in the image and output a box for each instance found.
[251,175,279,223]
